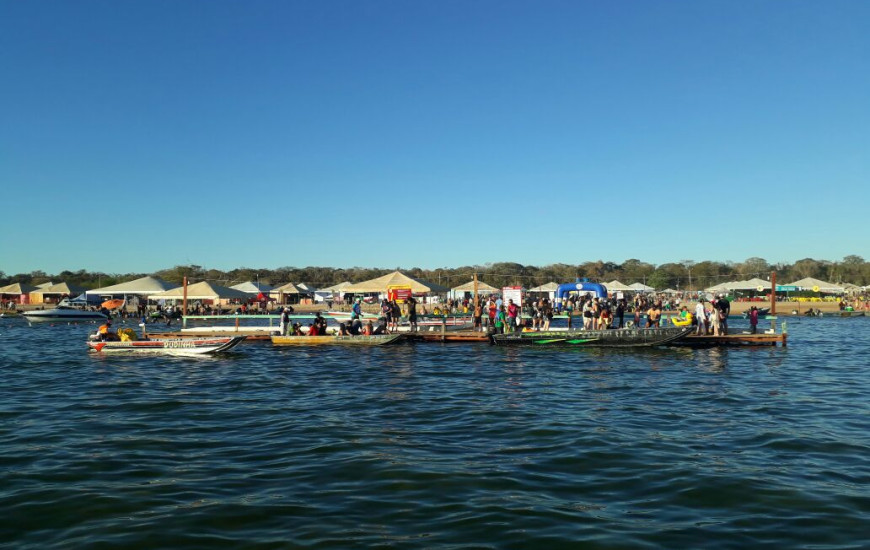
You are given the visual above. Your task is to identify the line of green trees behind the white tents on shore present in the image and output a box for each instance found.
[0,255,870,290]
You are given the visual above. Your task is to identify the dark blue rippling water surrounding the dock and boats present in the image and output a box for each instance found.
[0,318,870,549]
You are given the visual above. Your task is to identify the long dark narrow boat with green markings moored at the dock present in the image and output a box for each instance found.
[492,327,694,348]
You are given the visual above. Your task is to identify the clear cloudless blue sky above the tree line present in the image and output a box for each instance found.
[0,0,870,274]
